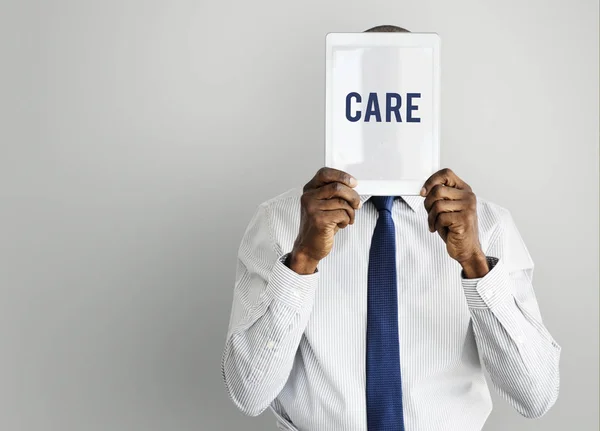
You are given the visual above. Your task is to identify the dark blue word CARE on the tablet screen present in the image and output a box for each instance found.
[346,92,421,123]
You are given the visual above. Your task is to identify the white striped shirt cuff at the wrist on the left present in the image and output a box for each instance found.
[267,253,320,309]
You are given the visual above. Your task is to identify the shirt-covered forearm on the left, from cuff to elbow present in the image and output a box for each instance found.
[222,256,318,416]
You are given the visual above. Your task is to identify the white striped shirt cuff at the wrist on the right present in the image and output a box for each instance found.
[461,256,512,308]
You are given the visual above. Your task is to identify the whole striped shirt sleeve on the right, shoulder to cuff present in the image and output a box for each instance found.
[462,209,561,418]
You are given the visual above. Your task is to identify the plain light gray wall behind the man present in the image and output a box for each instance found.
[0,0,599,431]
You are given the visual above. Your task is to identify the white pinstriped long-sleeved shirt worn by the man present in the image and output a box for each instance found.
[221,189,561,431]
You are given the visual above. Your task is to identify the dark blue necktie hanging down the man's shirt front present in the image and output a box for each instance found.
[366,196,404,431]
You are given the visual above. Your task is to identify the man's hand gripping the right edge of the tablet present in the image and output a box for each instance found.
[421,168,489,278]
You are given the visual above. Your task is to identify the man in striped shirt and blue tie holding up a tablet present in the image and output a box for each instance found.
[222,26,560,431]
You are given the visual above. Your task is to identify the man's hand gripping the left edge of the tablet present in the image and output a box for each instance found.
[289,168,362,274]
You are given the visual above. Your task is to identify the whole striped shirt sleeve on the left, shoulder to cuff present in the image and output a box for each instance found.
[221,202,320,416]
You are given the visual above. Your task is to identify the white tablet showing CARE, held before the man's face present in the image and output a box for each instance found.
[325,33,440,196]
